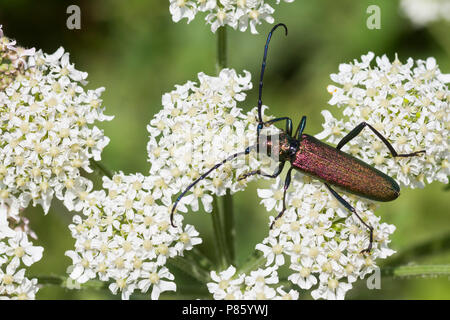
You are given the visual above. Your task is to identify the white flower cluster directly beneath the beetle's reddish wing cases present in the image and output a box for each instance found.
[256,173,395,299]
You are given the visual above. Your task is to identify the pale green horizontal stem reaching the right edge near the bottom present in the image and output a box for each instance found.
[381,265,450,277]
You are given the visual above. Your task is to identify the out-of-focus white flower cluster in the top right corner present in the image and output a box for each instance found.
[400,0,450,26]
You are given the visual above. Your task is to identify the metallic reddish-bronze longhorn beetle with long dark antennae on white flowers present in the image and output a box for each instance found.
[170,23,425,253]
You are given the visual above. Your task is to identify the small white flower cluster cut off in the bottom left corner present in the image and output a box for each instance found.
[0,216,44,300]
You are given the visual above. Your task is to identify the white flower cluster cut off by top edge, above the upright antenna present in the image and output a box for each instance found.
[169,0,294,34]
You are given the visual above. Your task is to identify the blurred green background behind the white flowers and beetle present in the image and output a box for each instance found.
[0,0,450,299]
